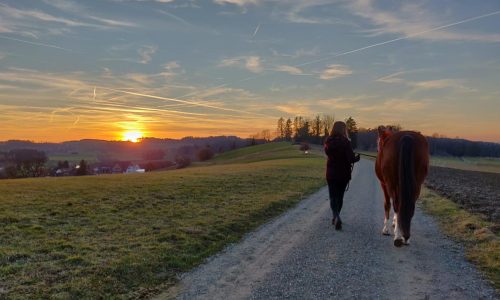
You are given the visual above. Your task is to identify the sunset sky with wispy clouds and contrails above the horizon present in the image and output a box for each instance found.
[0,0,500,142]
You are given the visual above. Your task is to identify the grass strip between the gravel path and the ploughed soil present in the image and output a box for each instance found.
[419,188,500,291]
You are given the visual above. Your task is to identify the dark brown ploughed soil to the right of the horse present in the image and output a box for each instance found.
[426,167,500,224]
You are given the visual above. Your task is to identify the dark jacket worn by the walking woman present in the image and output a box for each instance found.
[325,135,359,182]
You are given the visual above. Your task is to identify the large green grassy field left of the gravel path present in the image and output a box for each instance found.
[0,143,324,299]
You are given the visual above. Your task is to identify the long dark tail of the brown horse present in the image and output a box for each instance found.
[398,135,417,240]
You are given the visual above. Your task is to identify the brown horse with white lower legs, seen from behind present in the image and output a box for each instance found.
[375,128,429,247]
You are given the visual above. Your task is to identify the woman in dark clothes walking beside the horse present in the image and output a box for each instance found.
[324,121,359,230]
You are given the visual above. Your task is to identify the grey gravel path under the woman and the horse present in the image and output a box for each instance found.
[159,160,497,299]
